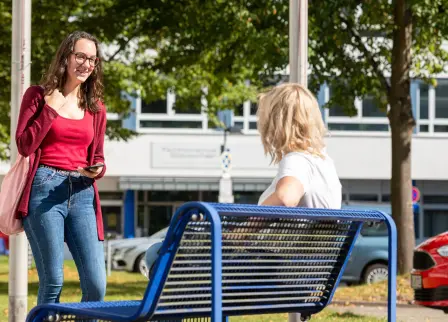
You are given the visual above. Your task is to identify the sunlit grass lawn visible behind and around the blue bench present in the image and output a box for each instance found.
[0,256,392,322]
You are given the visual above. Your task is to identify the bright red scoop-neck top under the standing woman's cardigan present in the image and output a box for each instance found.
[40,111,94,171]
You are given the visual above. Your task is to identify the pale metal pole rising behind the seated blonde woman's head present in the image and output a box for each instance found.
[288,0,308,322]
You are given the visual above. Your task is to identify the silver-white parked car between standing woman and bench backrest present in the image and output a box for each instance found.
[112,227,168,276]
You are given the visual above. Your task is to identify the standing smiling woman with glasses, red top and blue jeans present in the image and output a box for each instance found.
[16,31,106,304]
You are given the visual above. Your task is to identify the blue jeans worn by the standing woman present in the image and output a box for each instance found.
[23,167,106,304]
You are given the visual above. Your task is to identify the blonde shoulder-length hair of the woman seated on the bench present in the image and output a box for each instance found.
[257,83,326,164]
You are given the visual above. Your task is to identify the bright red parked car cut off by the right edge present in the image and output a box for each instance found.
[411,231,448,314]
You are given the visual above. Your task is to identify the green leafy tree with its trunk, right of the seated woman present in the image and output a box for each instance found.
[309,0,448,273]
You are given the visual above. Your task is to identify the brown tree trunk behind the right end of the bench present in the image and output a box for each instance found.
[389,0,415,274]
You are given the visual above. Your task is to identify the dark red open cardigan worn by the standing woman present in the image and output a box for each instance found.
[16,86,106,240]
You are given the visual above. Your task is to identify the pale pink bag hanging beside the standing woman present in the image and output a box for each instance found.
[0,154,30,235]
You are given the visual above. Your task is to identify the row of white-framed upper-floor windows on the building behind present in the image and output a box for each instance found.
[116,79,448,133]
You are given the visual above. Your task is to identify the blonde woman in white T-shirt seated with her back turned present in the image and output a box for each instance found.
[258,84,342,209]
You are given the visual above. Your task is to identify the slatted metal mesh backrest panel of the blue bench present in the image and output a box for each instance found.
[156,215,360,316]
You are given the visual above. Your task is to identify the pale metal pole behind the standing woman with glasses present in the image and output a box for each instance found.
[8,0,31,322]
